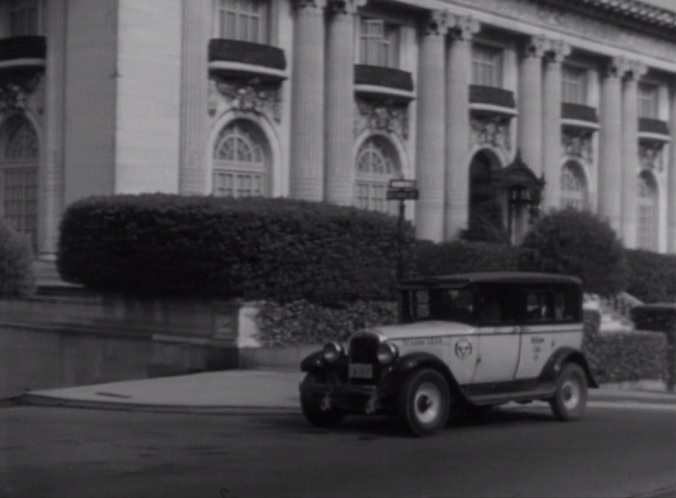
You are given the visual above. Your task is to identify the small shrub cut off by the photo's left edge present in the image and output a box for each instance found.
[0,219,35,297]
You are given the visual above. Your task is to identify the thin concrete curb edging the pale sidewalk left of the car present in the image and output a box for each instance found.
[15,394,301,415]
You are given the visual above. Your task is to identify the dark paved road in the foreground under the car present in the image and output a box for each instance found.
[0,406,676,497]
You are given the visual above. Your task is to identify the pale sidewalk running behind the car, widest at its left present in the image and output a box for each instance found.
[10,370,676,414]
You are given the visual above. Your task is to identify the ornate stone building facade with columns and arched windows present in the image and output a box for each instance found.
[0,0,676,256]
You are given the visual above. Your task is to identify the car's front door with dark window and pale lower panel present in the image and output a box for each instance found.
[472,284,520,384]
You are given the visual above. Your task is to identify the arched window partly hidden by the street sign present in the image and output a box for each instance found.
[355,136,401,214]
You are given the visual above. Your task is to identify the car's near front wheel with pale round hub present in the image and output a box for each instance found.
[398,368,451,437]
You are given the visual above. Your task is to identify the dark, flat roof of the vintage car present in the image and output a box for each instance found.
[399,271,582,287]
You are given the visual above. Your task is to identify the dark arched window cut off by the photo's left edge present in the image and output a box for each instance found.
[0,116,40,246]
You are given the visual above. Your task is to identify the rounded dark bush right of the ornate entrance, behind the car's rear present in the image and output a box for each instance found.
[522,208,627,295]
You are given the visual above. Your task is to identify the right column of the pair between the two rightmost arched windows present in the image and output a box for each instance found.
[621,61,647,249]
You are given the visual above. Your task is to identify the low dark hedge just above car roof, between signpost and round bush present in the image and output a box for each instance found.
[415,241,532,275]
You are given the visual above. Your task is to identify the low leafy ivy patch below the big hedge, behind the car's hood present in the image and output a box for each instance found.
[256,300,398,346]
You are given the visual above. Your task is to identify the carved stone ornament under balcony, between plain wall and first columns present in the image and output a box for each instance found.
[213,78,282,123]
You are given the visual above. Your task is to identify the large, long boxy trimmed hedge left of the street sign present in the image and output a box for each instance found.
[58,194,413,303]
